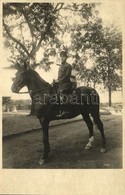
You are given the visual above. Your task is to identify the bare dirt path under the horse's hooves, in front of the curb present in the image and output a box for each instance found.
[3,112,122,169]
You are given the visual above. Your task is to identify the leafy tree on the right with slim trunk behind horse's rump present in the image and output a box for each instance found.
[72,4,122,106]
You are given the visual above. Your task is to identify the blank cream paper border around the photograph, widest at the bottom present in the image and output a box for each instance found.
[0,0,125,195]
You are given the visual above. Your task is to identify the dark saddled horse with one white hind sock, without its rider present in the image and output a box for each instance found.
[11,64,107,165]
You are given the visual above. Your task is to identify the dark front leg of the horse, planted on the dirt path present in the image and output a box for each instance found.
[39,118,50,165]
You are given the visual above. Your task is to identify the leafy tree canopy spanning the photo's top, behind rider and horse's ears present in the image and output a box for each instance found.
[3,3,122,94]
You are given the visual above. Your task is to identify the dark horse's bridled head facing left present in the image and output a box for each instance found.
[11,63,29,93]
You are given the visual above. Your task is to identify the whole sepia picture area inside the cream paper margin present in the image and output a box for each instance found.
[2,2,123,169]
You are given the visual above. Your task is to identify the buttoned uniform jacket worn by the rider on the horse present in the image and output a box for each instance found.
[58,62,72,90]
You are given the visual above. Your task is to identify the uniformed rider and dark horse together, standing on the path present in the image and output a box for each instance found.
[11,58,107,165]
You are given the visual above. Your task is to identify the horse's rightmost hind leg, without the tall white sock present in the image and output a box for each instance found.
[92,114,107,153]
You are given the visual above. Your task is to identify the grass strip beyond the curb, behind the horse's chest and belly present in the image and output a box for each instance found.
[2,111,82,136]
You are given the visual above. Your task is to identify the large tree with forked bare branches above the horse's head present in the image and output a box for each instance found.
[3,3,98,70]
